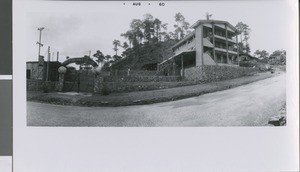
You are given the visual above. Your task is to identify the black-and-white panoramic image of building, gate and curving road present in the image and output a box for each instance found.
[24,1,293,127]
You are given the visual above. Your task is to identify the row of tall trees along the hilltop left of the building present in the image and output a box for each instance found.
[93,12,191,68]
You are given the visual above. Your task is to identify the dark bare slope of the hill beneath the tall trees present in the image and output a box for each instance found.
[111,39,176,70]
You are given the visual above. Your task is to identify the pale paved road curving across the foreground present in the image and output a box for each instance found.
[27,73,286,126]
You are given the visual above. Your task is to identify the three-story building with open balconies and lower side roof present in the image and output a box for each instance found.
[158,20,239,75]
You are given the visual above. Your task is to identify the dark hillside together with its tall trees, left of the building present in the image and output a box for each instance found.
[112,13,191,70]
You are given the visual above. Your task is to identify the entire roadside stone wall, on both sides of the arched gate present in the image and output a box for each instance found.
[27,65,259,94]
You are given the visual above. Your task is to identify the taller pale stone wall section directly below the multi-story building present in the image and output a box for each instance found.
[184,65,259,83]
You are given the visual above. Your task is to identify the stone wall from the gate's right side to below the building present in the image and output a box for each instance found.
[94,65,258,94]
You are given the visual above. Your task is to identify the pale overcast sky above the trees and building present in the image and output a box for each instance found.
[22,0,292,61]
